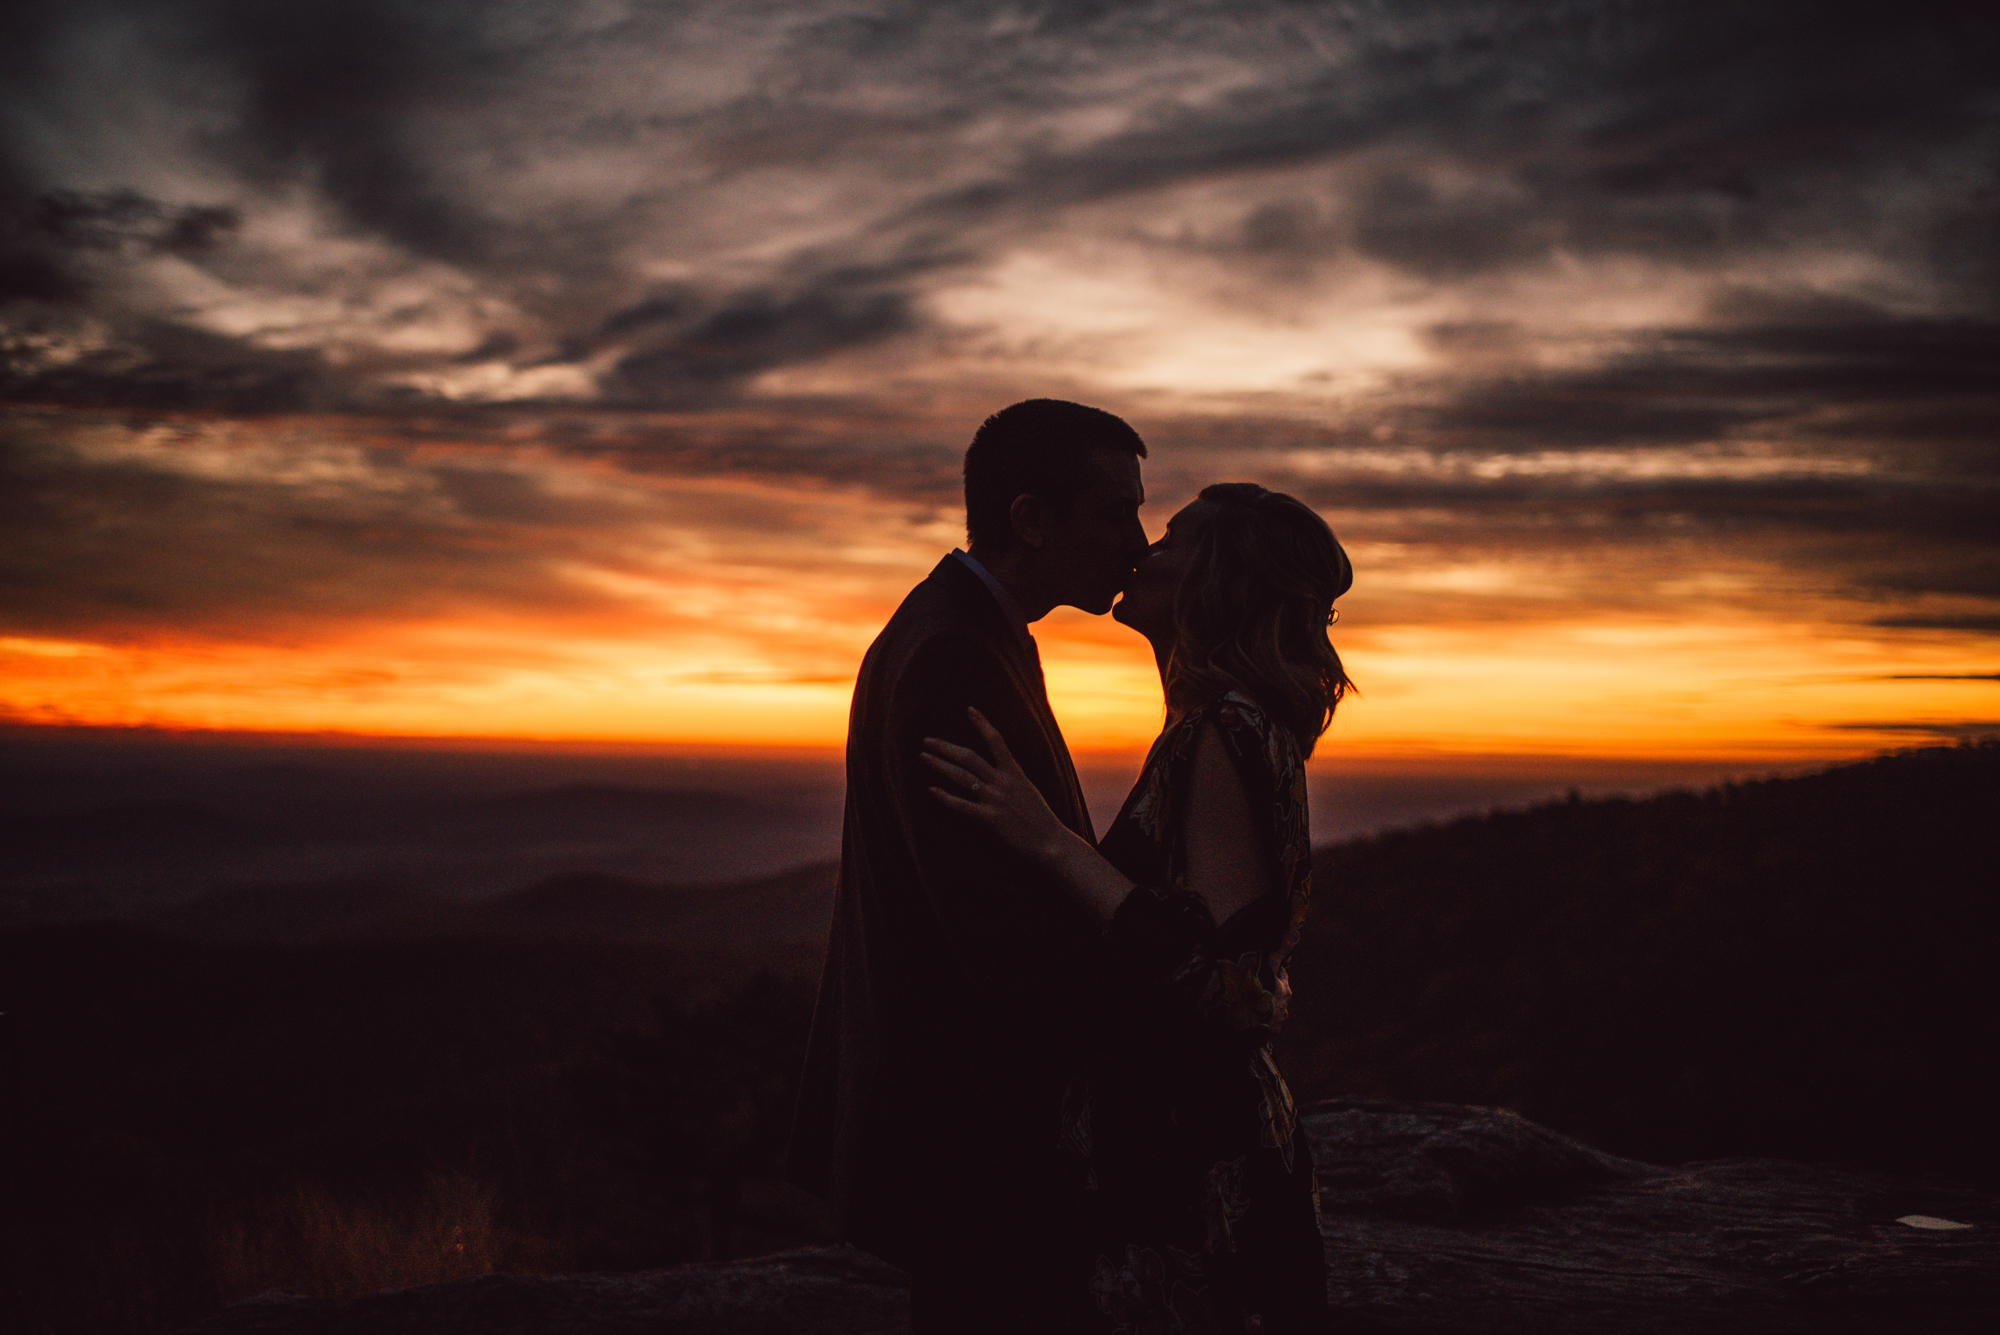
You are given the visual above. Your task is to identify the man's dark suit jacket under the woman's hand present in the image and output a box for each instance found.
[788,556,1106,1269]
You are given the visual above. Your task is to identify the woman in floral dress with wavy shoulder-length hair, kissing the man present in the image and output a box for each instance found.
[924,484,1354,1335]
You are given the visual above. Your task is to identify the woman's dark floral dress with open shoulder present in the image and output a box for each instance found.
[1064,691,1326,1335]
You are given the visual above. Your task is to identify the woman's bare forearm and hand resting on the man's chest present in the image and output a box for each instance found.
[924,709,1144,923]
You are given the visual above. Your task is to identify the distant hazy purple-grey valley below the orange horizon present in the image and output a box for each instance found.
[0,729,1784,943]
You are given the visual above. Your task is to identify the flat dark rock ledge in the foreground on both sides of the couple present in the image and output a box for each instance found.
[188,1099,2000,1335]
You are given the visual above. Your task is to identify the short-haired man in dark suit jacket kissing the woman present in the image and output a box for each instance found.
[788,400,1146,1335]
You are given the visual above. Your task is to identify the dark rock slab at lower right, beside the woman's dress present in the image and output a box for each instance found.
[1306,1101,2000,1335]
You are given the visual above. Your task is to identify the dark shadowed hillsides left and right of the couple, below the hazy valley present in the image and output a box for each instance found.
[0,743,2000,1335]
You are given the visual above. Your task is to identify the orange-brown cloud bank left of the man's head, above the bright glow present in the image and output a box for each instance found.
[0,391,976,651]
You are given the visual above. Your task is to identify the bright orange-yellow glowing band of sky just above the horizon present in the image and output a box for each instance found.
[0,600,2000,763]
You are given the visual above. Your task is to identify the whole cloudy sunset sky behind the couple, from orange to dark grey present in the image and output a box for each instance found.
[0,0,2000,767]
